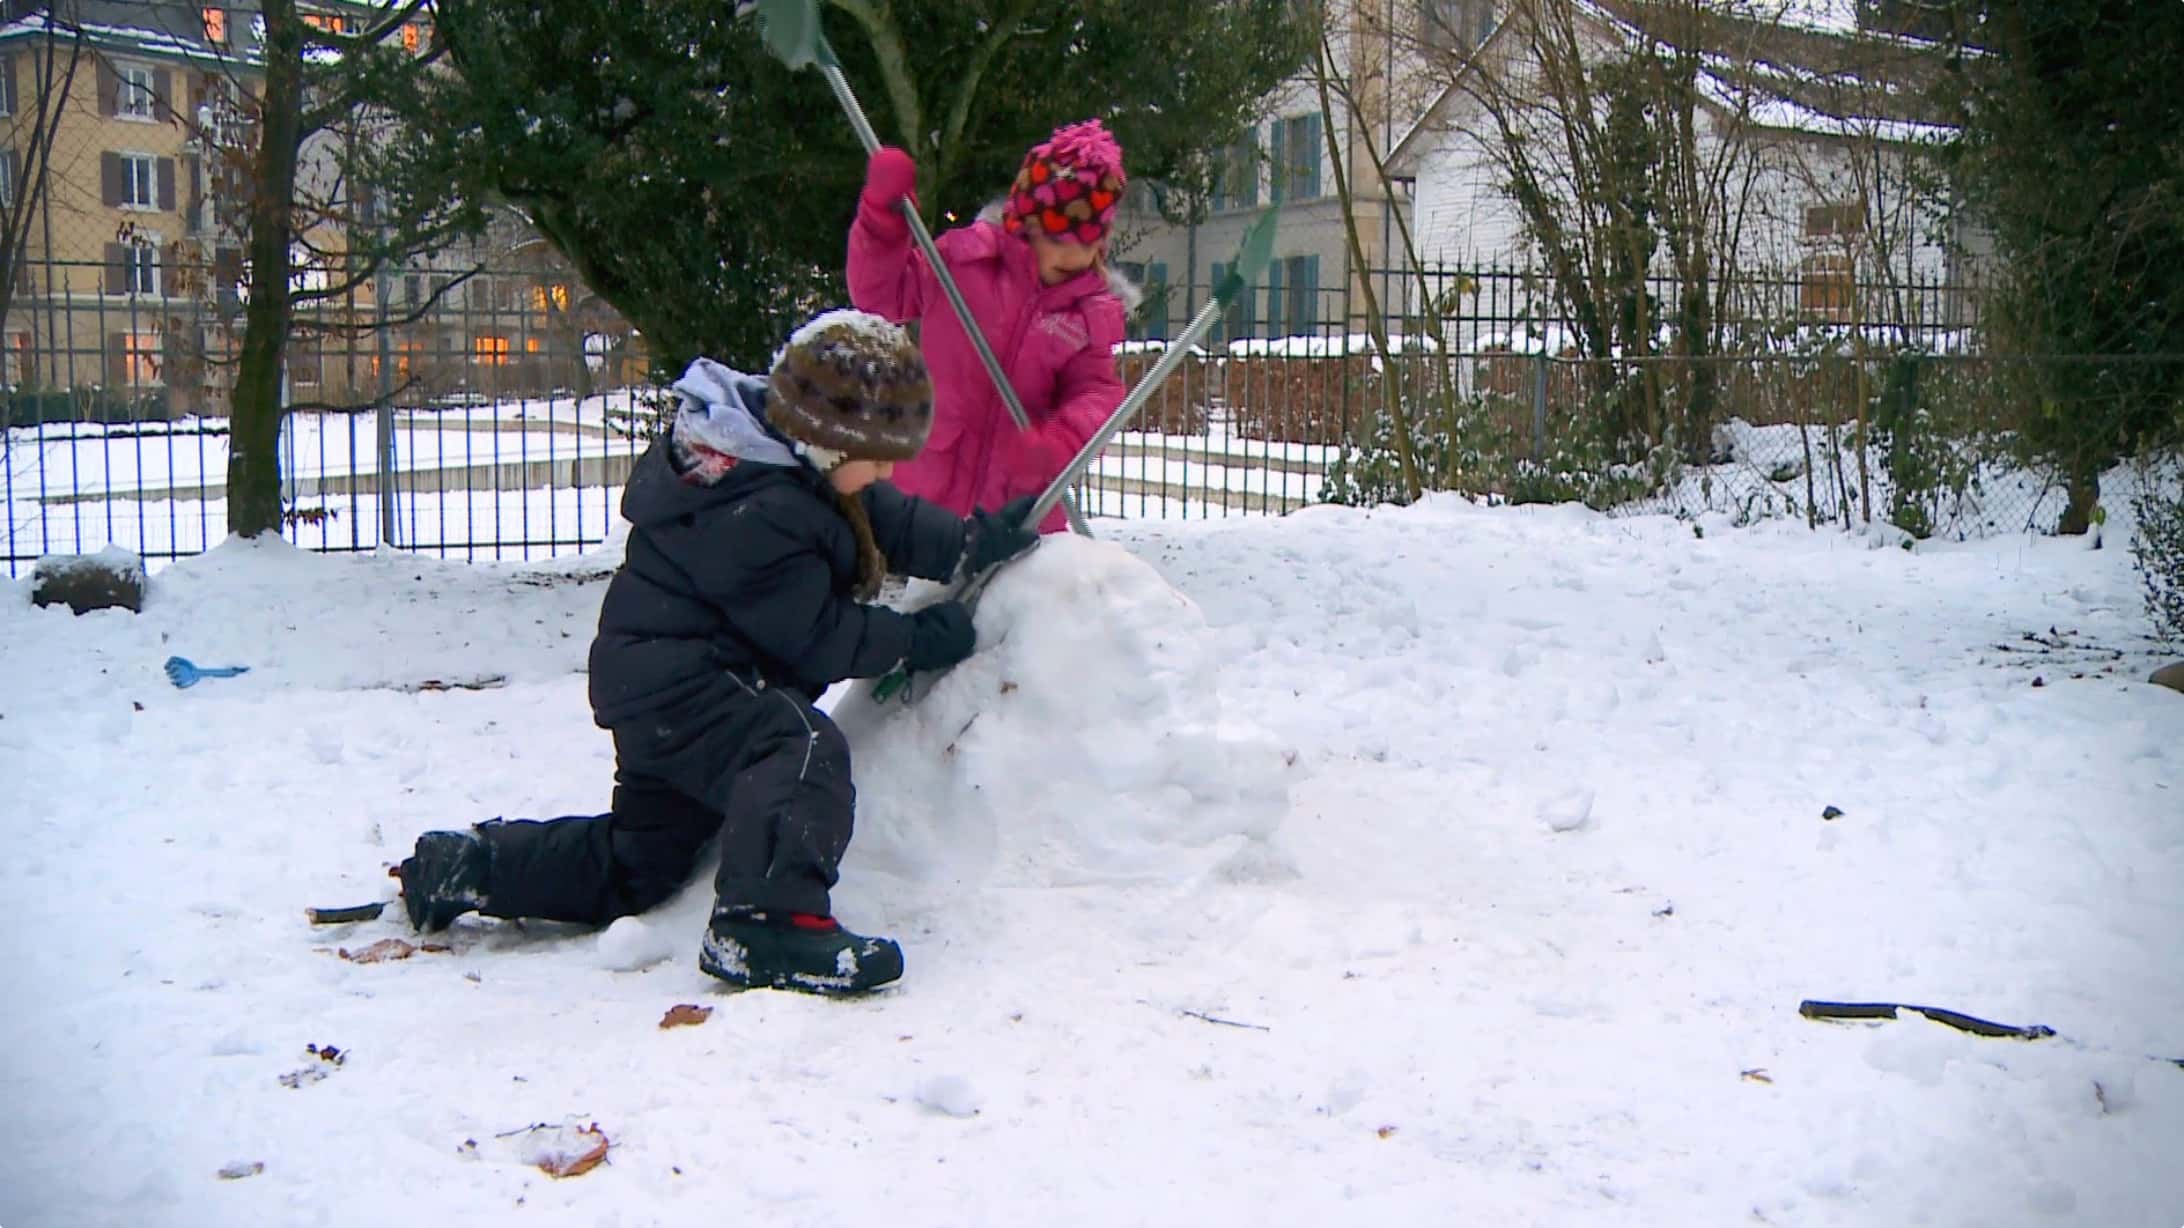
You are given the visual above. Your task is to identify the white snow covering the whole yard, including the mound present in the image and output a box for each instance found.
[0,498,2184,1228]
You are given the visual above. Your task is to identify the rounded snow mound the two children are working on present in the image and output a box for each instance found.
[834,535,1293,887]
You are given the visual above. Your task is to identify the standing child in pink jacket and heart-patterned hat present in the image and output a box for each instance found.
[850,120,1125,533]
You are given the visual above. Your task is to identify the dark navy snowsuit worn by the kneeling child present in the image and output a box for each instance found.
[478,406,963,924]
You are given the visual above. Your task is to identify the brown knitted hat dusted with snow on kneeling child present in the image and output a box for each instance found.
[767,310,933,461]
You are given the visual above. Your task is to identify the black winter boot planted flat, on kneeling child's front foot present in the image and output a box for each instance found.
[697,909,902,994]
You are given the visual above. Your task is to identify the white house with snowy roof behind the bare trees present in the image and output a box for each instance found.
[1389,0,1981,338]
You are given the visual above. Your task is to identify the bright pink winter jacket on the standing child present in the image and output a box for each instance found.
[850,212,1123,533]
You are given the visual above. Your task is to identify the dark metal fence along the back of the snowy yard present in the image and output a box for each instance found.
[0,253,2122,575]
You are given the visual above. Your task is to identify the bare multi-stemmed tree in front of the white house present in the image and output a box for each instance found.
[1422,0,1780,459]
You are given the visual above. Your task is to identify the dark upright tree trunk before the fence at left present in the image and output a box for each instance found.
[227,0,304,538]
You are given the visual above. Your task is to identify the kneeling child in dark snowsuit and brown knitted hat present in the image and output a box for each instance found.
[400,310,1033,994]
